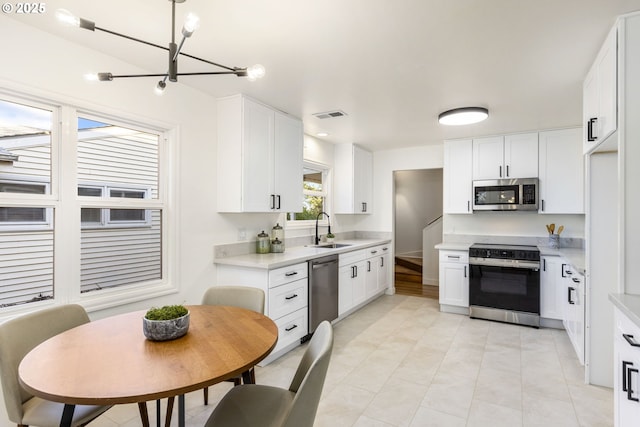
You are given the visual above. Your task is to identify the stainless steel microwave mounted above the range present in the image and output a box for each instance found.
[473,178,538,211]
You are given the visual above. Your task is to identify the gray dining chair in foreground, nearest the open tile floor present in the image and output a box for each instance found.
[205,320,333,427]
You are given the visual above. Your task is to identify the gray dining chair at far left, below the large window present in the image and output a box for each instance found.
[0,304,111,427]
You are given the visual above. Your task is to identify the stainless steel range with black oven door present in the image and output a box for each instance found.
[469,244,540,328]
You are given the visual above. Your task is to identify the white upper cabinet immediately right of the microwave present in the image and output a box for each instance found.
[538,128,584,214]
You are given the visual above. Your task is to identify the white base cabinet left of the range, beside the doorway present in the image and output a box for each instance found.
[440,250,469,314]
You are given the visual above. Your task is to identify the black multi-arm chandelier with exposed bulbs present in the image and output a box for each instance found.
[56,0,265,94]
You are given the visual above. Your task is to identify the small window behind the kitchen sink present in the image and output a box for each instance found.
[287,162,330,227]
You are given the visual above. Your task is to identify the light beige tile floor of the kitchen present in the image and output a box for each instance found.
[91,295,613,427]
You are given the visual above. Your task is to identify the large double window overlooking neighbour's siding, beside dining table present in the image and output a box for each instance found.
[0,92,175,310]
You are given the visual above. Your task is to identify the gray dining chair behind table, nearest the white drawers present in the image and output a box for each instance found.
[165,286,265,426]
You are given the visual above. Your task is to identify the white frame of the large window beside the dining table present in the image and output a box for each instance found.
[0,89,180,322]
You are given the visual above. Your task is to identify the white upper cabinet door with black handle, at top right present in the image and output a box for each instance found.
[583,27,618,153]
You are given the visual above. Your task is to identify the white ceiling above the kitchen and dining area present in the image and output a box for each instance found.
[8,0,640,150]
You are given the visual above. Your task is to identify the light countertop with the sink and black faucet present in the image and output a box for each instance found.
[214,239,391,270]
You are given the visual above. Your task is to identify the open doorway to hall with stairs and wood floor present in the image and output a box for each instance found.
[393,168,442,299]
